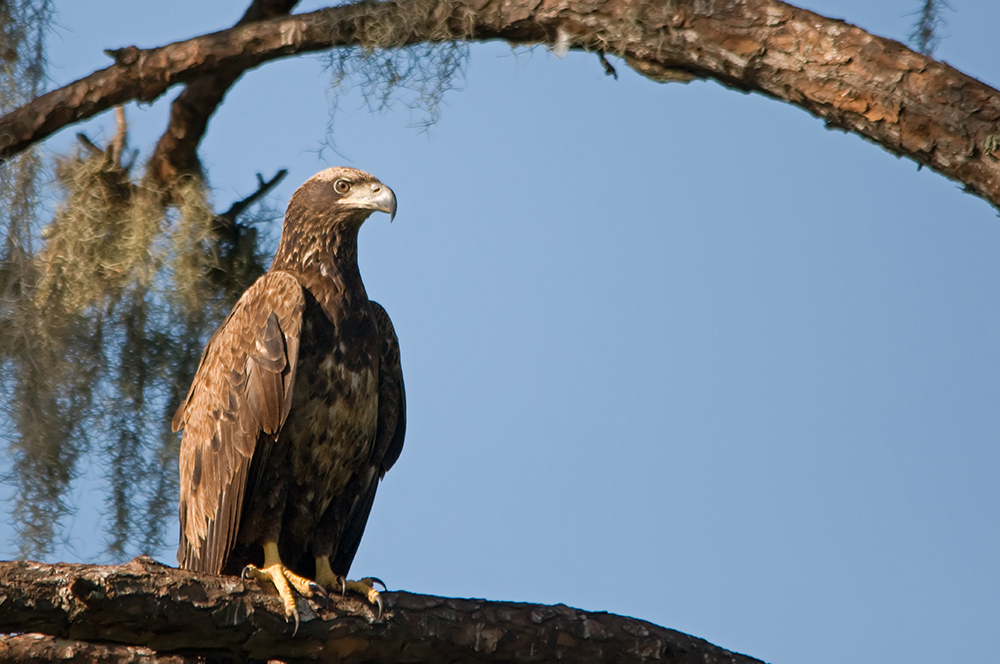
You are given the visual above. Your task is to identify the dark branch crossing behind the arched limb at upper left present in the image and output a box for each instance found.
[146,0,298,190]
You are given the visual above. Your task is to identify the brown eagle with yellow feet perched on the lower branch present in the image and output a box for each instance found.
[173,168,406,629]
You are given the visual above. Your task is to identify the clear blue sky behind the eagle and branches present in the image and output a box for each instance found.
[0,0,1000,664]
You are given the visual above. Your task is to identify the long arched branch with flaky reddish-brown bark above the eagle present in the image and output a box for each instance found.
[0,0,1000,208]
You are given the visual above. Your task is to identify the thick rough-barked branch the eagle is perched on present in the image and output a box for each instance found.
[0,557,758,664]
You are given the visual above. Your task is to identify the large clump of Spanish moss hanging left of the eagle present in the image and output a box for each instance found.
[0,123,274,559]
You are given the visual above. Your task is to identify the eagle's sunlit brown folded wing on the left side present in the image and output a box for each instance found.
[173,272,305,574]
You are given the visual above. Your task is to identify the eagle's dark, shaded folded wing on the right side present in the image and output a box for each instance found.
[330,302,406,576]
